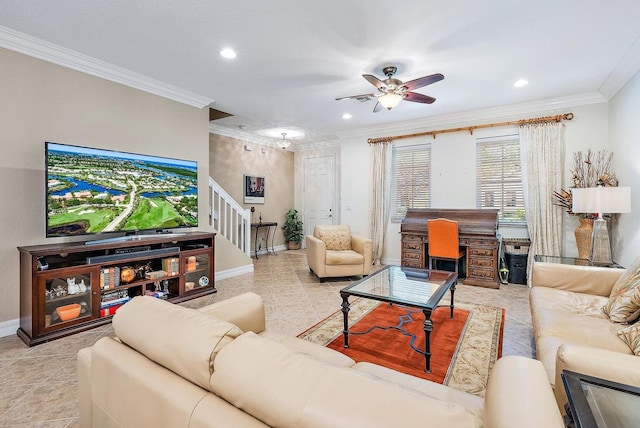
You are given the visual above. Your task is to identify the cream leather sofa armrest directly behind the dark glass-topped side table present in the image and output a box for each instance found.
[554,343,640,412]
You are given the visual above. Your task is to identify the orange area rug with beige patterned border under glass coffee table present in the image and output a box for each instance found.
[299,299,504,396]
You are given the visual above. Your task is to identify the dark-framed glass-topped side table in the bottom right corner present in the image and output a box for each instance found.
[556,370,640,428]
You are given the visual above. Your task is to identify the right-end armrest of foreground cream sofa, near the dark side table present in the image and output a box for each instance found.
[484,355,565,428]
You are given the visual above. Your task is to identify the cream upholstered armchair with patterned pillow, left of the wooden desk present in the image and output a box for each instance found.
[306,225,372,282]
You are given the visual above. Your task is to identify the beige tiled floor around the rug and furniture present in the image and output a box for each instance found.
[0,251,534,427]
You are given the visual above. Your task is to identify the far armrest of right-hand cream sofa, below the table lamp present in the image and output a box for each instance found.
[531,262,625,297]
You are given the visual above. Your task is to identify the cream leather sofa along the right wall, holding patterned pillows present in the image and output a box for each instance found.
[529,262,640,411]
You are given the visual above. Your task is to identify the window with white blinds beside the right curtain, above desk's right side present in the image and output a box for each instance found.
[476,135,525,223]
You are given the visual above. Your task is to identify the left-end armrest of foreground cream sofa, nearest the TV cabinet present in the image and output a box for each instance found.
[199,292,266,334]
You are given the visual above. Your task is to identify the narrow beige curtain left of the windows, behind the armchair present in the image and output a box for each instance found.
[369,141,391,265]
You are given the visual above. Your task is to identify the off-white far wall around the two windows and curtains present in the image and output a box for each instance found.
[341,103,618,264]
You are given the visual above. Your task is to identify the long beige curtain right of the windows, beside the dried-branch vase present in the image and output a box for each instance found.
[520,122,564,284]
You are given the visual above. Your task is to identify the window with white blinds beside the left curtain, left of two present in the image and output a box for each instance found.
[391,144,431,222]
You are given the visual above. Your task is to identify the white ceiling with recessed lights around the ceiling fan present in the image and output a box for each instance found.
[0,0,640,142]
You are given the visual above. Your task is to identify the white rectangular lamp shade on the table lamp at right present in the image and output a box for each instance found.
[571,186,631,214]
